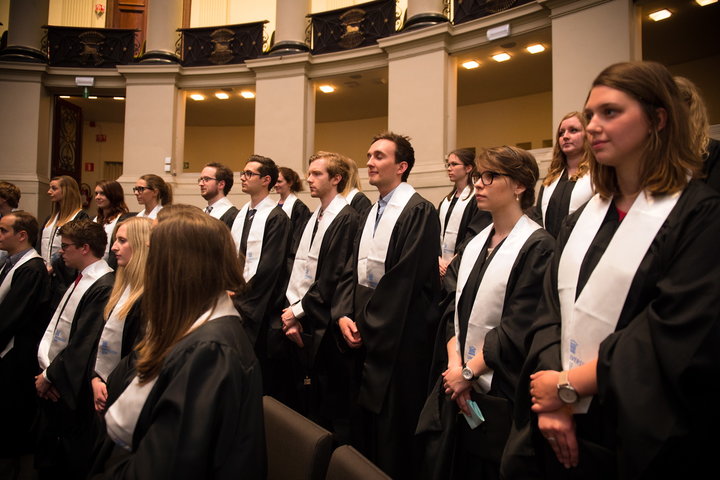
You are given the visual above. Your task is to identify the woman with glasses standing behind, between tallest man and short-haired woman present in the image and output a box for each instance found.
[438,148,491,277]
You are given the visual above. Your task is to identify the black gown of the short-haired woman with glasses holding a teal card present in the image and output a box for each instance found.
[418,229,555,479]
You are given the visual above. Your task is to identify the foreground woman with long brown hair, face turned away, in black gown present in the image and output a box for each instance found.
[100,211,265,479]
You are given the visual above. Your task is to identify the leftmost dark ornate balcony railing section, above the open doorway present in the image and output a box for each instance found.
[43,25,136,68]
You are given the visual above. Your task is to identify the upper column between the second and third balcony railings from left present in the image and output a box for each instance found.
[270,0,311,55]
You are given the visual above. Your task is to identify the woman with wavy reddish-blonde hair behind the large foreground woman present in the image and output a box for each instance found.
[530,112,594,237]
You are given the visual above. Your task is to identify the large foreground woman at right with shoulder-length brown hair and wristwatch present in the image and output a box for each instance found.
[503,62,720,478]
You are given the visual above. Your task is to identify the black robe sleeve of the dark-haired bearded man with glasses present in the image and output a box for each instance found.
[233,207,291,344]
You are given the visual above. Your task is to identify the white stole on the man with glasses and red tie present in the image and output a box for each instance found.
[38,260,113,370]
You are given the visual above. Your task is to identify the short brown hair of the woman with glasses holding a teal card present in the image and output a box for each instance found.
[477,145,540,210]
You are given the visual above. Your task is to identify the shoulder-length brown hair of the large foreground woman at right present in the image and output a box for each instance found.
[588,62,702,198]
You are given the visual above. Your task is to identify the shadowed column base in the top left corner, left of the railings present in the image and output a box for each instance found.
[0,0,50,63]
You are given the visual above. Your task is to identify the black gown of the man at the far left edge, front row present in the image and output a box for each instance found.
[0,258,50,458]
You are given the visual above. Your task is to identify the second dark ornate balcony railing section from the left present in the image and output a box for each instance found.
[178,21,267,67]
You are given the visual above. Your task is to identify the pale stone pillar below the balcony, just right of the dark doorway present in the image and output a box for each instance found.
[118,65,184,204]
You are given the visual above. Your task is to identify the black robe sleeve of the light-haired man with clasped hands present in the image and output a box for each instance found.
[300,205,358,358]
